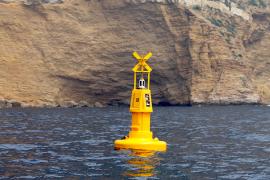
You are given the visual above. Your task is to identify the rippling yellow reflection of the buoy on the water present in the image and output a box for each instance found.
[123,150,160,177]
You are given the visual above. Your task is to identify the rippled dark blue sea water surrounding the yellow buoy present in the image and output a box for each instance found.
[0,106,270,180]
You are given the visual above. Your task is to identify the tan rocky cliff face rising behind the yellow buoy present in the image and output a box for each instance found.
[0,0,270,107]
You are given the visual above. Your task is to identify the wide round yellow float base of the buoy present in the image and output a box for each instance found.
[114,137,167,151]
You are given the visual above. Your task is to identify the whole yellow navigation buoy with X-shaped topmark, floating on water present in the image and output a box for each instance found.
[114,52,167,151]
